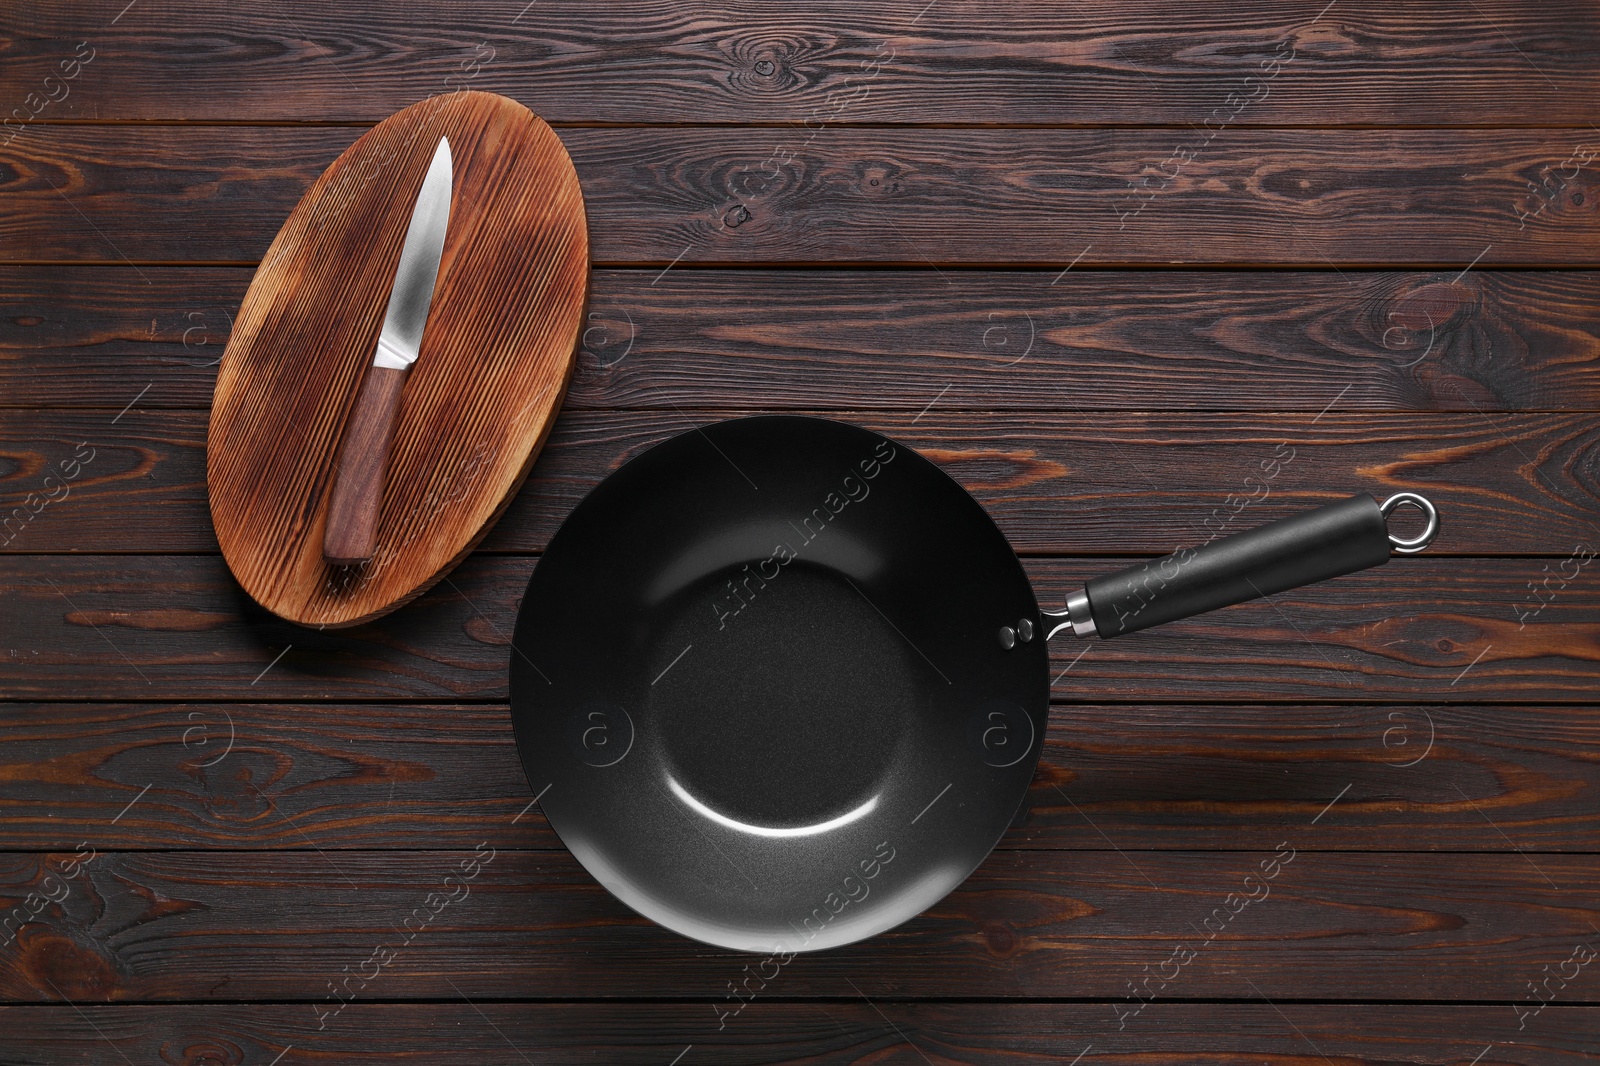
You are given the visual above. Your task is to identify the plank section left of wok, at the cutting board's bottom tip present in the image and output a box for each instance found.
[0,555,518,699]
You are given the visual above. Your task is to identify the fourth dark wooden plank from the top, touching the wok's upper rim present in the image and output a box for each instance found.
[0,406,1600,555]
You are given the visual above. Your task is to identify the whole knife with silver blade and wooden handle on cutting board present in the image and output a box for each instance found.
[322,138,454,565]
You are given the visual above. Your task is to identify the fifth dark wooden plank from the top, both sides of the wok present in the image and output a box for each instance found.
[0,555,1600,704]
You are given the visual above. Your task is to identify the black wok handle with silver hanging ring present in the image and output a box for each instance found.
[1051,493,1438,637]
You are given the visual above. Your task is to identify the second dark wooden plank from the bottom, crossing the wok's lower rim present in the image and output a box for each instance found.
[0,845,1600,998]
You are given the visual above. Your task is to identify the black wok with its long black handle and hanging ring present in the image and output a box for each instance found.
[510,416,1438,952]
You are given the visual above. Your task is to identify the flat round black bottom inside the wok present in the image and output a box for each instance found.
[642,560,921,836]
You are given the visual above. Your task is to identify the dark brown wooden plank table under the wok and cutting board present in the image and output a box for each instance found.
[0,0,1600,1066]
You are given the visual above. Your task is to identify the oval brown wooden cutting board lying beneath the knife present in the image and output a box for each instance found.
[206,93,589,627]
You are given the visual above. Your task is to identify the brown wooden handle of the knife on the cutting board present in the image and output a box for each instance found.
[322,367,406,565]
